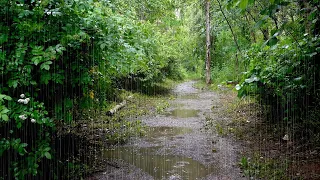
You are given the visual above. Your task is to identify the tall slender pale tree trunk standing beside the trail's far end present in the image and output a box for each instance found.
[206,0,211,84]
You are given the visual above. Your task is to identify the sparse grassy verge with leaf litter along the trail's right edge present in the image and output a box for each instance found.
[206,90,289,180]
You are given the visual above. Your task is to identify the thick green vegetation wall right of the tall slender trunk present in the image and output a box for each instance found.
[211,0,320,142]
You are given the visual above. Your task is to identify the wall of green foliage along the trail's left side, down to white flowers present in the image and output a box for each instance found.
[0,0,187,179]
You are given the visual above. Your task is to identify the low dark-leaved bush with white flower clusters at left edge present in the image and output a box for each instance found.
[0,94,55,179]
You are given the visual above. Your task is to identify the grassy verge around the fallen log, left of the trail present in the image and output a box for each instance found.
[52,80,176,176]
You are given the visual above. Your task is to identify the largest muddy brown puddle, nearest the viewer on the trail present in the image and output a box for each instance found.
[104,147,216,180]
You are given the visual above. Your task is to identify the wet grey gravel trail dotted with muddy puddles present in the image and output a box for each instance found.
[90,81,243,180]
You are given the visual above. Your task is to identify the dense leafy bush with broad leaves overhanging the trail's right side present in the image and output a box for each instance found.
[238,32,320,124]
